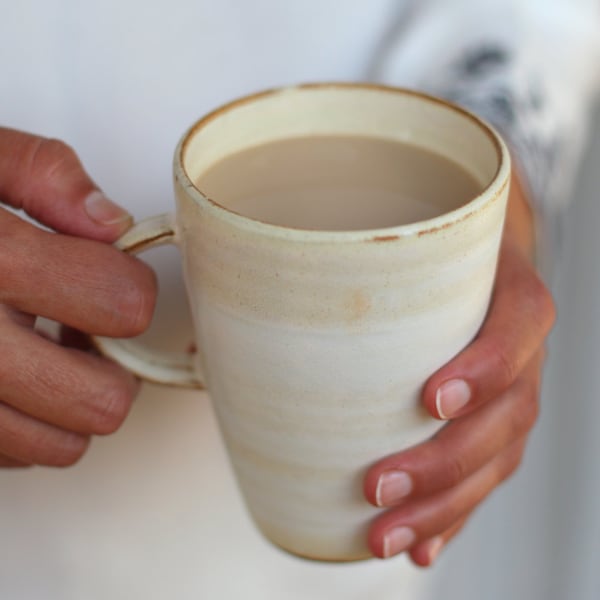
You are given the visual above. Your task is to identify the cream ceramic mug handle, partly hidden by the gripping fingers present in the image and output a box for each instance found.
[92,214,205,389]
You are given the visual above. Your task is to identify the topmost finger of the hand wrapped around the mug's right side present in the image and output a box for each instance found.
[423,244,555,419]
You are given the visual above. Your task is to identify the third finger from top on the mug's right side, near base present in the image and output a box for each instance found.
[368,439,525,558]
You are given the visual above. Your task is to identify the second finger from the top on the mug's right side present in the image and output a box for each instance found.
[364,354,541,507]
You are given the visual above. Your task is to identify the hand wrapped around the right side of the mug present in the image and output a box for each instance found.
[365,176,555,566]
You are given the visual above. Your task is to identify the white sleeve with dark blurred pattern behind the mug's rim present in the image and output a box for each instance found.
[375,0,600,268]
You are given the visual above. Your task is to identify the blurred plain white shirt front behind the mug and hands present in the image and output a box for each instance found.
[0,0,600,600]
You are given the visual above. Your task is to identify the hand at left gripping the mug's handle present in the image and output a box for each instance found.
[0,128,156,467]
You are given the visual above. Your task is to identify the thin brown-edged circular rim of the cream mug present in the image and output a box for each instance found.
[173,82,511,242]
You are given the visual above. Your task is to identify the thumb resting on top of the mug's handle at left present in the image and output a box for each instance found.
[0,127,132,242]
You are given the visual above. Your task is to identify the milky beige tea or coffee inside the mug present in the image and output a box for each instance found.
[196,135,483,231]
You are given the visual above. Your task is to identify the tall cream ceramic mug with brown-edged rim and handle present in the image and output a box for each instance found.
[96,84,510,561]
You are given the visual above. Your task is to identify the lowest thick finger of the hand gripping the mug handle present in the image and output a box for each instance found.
[0,403,89,467]
